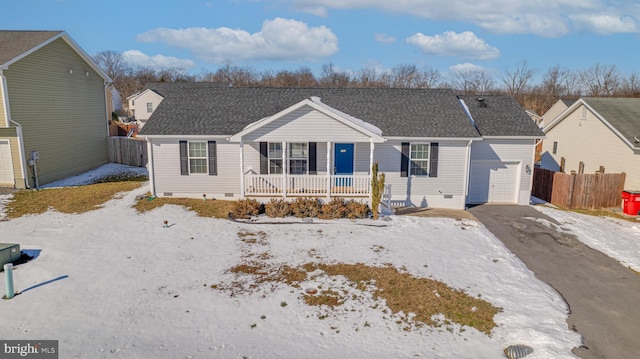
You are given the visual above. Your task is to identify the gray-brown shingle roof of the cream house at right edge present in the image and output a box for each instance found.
[582,97,640,146]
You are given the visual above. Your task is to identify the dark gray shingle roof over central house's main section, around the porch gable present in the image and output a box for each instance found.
[140,85,537,138]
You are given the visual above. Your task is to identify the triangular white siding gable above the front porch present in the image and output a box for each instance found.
[244,106,369,143]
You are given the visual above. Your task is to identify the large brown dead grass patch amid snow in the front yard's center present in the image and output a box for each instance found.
[211,230,501,335]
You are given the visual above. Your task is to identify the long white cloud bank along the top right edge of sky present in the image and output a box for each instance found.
[286,0,640,37]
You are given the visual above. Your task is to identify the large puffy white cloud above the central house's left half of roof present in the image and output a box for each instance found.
[137,18,338,63]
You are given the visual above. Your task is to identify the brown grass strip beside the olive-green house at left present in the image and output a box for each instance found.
[5,181,142,218]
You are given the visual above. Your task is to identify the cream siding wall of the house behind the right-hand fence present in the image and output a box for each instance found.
[542,107,640,190]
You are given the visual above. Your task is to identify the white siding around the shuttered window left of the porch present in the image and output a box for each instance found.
[151,138,241,199]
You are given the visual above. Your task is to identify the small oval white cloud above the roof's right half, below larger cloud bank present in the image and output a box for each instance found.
[406,31,500,60]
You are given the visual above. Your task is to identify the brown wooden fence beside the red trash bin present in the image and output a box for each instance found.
[531,168,626,209]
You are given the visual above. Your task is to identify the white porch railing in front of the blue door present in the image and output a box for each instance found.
[244,174,371,197]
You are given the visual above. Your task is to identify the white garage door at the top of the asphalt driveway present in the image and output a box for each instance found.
[469,161,519,203]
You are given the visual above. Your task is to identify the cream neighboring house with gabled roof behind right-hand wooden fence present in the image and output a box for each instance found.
[541,97,640,190]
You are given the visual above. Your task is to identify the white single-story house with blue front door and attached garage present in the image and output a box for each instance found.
[139,87,543,209]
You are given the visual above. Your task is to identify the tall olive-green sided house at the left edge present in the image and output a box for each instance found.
[0,31,111,188]
